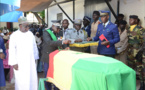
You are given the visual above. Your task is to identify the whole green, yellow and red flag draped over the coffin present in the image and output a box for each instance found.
[47,50,136,90]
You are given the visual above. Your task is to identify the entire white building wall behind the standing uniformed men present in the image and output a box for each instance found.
[45,0,145,28]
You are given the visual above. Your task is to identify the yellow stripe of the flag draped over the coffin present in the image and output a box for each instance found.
[54,50,101,90]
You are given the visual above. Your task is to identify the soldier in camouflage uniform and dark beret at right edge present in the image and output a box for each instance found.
[127,15,145,90]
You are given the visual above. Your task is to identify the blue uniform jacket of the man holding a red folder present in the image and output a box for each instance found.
[93,21,120,55]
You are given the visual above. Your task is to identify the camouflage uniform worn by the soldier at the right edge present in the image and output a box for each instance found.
[127,26,145,82]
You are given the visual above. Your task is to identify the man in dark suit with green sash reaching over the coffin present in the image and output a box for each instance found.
[41,20,71,90]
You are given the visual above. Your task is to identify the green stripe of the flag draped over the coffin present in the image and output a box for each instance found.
[71,56,136,90]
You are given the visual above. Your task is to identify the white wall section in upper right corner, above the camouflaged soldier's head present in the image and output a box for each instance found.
[120,0,145,27]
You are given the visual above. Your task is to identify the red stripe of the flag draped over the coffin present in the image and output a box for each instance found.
[47,50,59,78]
